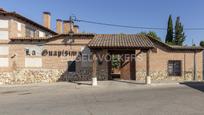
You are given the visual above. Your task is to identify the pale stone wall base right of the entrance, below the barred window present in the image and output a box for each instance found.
[136,71,202,81]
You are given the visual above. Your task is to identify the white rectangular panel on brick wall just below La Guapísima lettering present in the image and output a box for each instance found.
[25,58,42,67]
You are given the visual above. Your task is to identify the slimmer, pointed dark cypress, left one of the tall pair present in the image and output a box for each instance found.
[165,15,174,44]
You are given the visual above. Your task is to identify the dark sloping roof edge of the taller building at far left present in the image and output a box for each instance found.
[0,8,57,35]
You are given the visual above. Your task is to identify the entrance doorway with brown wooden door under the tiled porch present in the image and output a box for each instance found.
[108,50,136,80]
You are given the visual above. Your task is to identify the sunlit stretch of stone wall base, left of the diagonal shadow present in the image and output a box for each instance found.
[0,69,64,84]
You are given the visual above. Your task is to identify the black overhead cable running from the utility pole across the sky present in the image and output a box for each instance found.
[74,17,204,31]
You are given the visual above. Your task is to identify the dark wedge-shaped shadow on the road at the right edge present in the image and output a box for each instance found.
[180,82,204,92]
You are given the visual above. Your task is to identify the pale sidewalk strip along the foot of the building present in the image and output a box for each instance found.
[0,80,198,89]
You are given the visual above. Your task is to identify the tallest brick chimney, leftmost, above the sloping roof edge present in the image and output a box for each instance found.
[43,12,51,29]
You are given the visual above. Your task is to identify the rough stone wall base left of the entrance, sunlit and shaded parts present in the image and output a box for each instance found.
[0,67,92,84]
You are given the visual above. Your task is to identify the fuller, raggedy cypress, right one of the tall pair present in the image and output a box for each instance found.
[174,17,185,46]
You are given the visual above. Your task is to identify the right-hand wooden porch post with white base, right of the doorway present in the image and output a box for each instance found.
[145,49,151,84]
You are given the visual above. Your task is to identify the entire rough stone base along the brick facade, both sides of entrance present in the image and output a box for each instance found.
[0,68,202,84]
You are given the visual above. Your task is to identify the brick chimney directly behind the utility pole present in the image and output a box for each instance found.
[63,20,74,34]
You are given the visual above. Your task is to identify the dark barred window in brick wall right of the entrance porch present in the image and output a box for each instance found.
[168,60,181,76]
